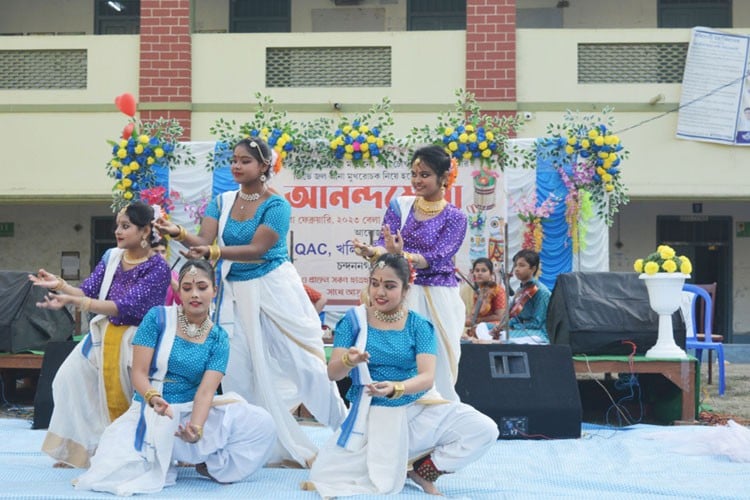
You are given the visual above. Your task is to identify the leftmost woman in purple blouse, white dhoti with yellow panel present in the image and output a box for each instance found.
[29,201,170,467]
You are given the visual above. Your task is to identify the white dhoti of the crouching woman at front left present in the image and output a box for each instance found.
[74,394,276,495]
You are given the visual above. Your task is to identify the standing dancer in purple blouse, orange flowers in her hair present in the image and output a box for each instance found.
[353,146,466,401]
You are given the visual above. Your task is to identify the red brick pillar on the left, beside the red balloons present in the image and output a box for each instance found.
[138,0,193,141]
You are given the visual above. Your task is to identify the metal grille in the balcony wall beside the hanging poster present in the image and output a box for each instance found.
[578,43,688,83]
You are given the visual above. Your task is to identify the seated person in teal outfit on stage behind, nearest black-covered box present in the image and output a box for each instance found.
[490,249,551,344]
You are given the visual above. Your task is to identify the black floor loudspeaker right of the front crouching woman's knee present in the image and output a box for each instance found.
[456,344,582,439]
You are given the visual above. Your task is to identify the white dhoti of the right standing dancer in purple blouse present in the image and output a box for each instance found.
[406,285,466,401]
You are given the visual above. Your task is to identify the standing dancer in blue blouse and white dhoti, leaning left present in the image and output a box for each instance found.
[157,138,346,466]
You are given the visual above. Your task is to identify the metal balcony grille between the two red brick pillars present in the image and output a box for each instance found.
[266,47,391,87]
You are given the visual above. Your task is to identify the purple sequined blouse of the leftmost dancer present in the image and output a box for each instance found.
[80,253,171,326]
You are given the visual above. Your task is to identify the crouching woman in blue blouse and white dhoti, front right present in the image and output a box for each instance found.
[303,254,498,497]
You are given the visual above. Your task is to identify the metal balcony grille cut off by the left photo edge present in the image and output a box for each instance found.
[0,49,88,90]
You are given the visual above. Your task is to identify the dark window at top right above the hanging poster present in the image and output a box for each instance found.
[657,0,732,28]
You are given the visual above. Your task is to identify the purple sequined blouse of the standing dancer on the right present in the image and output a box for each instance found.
[377,200,466,287]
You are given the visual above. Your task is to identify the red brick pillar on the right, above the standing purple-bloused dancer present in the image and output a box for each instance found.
[466,0,516,110]
